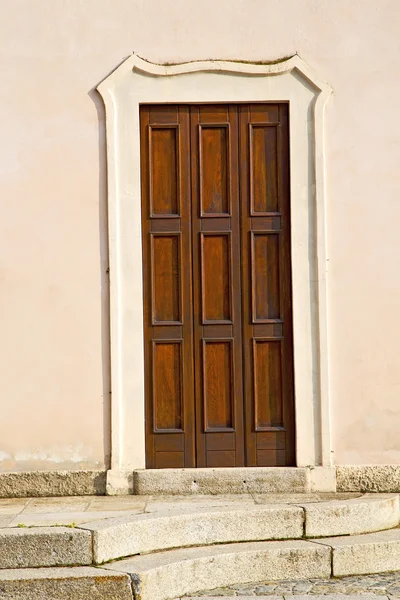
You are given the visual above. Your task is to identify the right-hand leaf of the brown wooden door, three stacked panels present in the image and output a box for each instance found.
[240,104,295,466]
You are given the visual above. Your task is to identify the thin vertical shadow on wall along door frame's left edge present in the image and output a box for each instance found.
[88,88,111,469]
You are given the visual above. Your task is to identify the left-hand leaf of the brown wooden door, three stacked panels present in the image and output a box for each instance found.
[140,106,195,468]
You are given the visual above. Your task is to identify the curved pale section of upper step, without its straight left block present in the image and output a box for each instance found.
[82,495,399,564]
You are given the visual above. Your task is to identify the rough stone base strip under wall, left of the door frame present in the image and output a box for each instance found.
[0,470,107,498]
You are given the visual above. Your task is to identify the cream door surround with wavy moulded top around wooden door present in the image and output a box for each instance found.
[97,55,332,471]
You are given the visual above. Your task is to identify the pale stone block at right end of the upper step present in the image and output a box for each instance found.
[301,495,399,537]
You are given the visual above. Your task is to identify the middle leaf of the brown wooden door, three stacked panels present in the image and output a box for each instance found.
[191,105,244,467]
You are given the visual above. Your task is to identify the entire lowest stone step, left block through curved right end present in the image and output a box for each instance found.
[0,529,400,600]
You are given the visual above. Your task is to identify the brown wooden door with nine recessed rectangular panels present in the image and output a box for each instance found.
[140,103,295,468]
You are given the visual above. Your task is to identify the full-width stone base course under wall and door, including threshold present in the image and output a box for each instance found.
[0,465,400,498]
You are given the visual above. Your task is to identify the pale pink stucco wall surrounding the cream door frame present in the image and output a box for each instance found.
[0,0,400,470]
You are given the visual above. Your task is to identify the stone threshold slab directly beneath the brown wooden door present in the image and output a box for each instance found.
[133,467,309,495]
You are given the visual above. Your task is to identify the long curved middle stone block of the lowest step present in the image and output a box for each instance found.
[106,540,331,600]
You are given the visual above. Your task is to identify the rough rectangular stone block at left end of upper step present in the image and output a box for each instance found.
[0,527,93,568]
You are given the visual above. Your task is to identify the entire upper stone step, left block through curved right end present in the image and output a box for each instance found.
[0,495,399,569]
